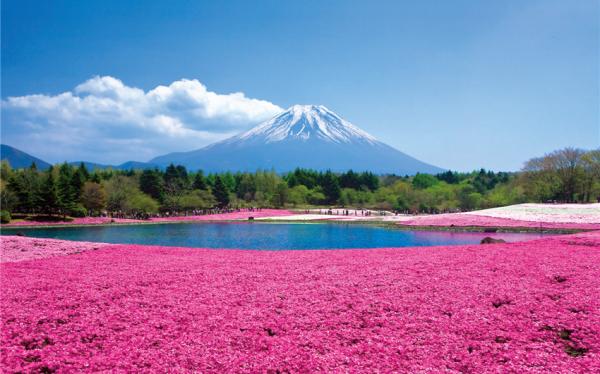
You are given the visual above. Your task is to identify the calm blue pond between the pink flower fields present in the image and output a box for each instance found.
[2,222,547,250]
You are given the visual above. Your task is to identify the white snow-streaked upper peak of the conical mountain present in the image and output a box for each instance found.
[227,105,377,144]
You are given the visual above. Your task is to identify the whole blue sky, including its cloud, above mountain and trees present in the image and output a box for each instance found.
[2,0,600,170]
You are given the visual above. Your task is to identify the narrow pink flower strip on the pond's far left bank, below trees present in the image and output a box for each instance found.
[2,209,293,227]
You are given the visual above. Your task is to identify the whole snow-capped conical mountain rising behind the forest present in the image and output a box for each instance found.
[150,105,443,175]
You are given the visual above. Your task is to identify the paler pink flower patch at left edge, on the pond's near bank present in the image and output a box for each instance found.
[0,236,108,263]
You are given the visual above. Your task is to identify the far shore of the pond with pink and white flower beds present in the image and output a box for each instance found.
[0,204,600,234]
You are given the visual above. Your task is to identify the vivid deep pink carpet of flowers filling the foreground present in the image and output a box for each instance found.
[0,232,600,373]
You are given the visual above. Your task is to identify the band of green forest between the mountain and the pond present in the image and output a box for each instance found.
[0,148,600,223]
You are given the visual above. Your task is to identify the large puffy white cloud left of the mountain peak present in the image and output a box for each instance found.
[2,76,283,163]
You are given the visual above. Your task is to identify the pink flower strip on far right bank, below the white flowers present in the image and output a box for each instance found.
[398,213,600,230]
